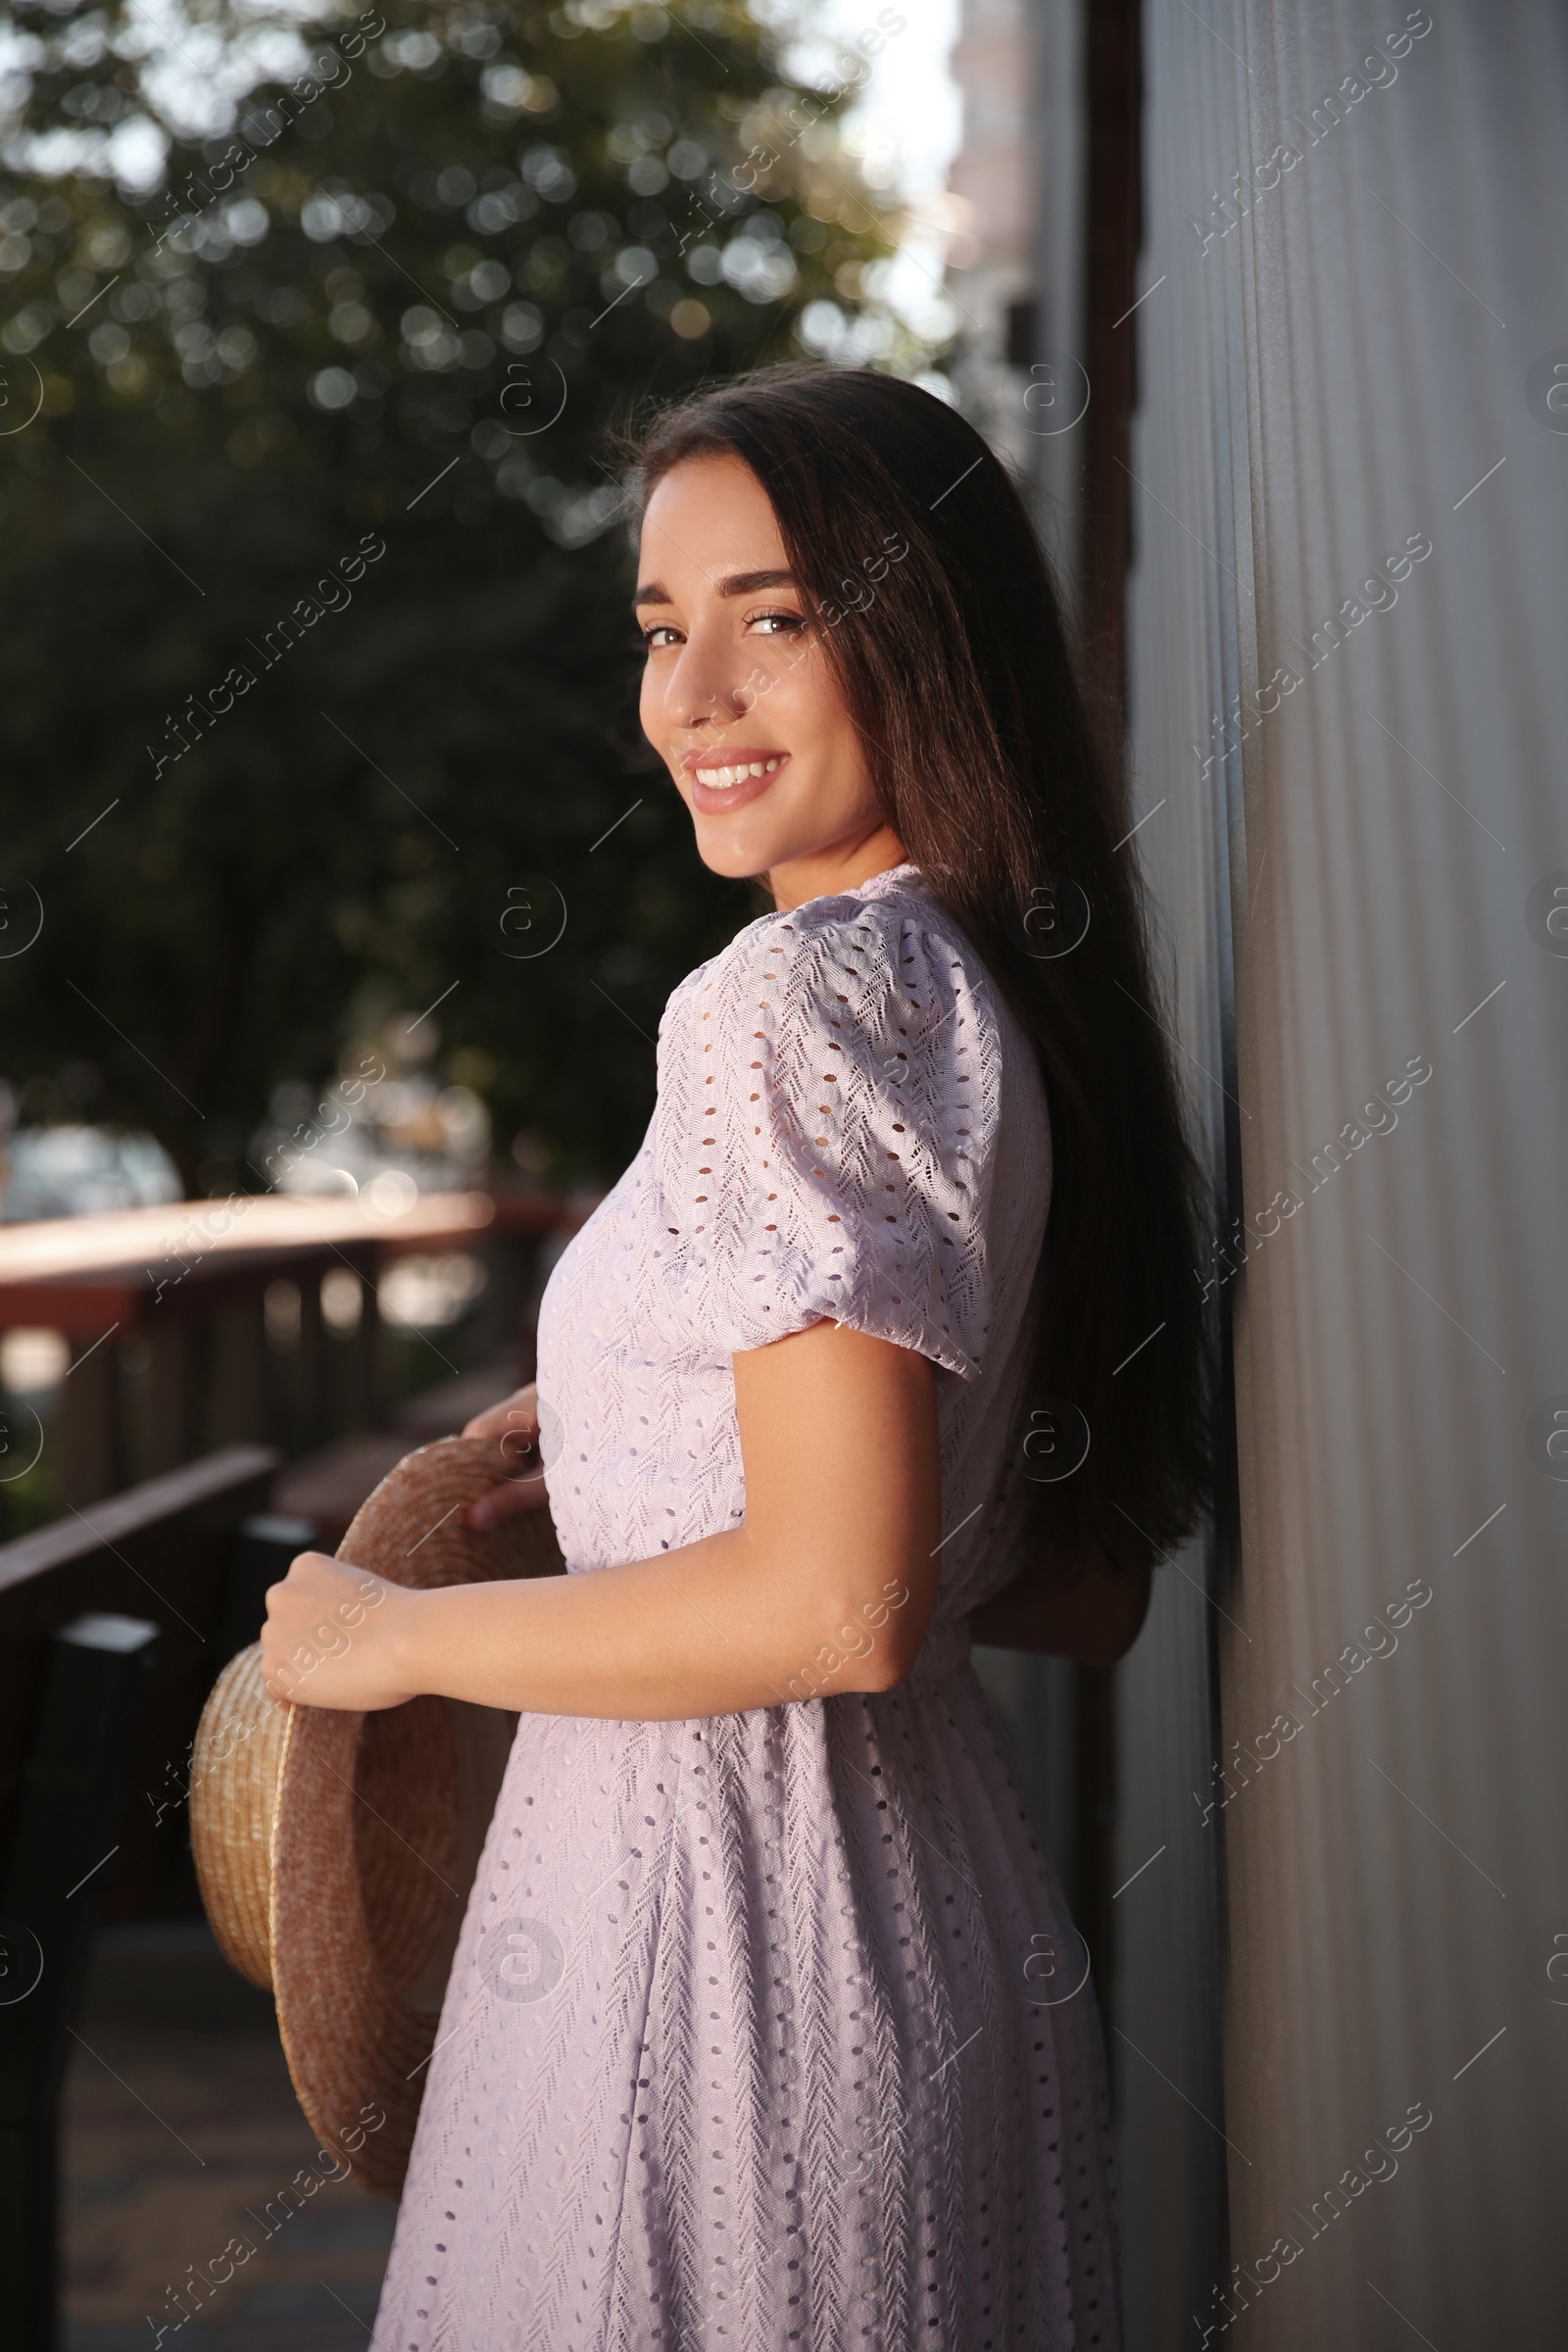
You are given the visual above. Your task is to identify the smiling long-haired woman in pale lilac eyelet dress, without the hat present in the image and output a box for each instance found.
[266,369,1206,2352]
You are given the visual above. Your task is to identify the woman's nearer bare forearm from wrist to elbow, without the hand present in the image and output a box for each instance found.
[388,1527,924,1722]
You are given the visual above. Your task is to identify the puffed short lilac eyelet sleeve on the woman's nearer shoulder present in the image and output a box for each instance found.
[654,894,999,1381]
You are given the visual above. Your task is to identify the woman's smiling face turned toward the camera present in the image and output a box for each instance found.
[635,457,906,907]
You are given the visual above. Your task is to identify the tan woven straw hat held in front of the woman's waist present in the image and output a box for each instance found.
[190,1437,562,2197]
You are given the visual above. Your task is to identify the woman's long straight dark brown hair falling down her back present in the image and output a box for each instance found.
[623,367,1213,1574]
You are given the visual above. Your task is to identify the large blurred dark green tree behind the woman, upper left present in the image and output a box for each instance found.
[0,0,924,1190]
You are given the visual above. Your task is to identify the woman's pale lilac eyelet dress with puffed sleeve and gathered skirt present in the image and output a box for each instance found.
[373,865,1121,2352]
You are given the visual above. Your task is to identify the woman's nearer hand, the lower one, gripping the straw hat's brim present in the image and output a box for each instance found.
[261,1552,416,1712]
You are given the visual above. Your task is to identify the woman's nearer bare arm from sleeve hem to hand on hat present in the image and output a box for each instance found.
[261,1322,943,1722]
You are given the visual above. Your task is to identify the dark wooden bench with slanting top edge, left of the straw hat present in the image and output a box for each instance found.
[0,1446,277,2352]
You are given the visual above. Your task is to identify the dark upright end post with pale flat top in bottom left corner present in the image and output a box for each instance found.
[0,1616,158,2352]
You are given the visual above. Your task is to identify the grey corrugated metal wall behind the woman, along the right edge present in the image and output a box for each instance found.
[1116,0,1568,2352]
